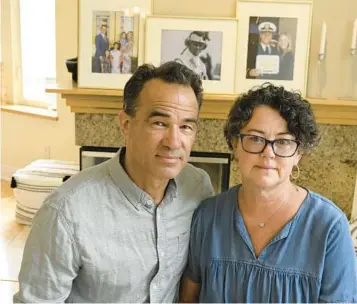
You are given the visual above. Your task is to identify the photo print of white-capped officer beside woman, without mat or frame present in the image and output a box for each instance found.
[246,17,297,80]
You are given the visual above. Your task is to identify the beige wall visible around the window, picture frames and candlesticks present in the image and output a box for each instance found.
[1,0,357,177]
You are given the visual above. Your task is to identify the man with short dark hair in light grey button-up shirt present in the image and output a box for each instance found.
[14,62,213,303]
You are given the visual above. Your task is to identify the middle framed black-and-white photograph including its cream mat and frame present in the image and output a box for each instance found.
[145,16,237,93]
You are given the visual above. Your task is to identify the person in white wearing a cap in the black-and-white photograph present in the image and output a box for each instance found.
[175,31,213,80]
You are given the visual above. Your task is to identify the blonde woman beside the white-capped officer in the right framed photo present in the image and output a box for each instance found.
[278,33,294,80]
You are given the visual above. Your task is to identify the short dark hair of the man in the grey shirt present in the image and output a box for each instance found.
[124,61,203,116]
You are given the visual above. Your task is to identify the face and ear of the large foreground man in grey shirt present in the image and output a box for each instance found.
[120,79,199,183]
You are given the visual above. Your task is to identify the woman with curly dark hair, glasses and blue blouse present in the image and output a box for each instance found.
[181,84,357,303]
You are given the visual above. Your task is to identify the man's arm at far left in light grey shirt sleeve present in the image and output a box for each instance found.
[14,201,80,303]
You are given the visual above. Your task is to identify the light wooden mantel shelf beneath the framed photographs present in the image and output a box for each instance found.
[46,87,357,125]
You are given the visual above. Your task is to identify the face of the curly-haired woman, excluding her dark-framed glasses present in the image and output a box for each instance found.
[232,106,301,188]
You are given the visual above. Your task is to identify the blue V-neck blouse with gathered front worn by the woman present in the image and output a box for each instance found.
[185,186,357,303]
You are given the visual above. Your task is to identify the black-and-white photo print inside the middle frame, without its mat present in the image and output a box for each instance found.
[161,29,222,80]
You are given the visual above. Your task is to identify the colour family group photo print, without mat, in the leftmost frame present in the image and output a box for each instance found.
[92,11,139,74]
